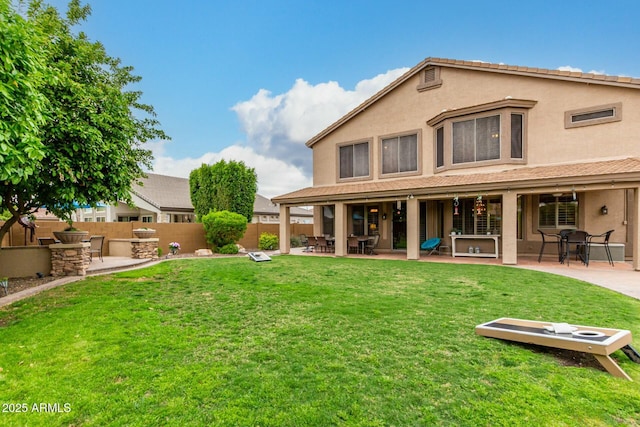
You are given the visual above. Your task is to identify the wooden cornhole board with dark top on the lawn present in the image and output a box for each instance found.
[476,317,640,381]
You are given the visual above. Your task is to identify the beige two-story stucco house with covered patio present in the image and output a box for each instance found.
[273,58,640,270]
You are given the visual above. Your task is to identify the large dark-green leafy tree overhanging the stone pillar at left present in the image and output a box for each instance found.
[0,0,167,239]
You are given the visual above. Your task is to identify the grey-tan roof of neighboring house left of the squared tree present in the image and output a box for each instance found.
[132,173,193,212]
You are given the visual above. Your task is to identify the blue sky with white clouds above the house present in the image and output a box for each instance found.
[42,0,640,197]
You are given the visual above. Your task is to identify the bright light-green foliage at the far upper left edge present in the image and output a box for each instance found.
[0,0,47,184]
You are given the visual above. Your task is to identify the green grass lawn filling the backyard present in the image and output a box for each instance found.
[0,256,640,426]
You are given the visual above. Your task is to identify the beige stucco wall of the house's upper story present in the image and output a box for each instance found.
[313,68,640,185]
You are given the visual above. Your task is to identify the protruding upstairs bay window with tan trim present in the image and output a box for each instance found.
[427,97,536,170]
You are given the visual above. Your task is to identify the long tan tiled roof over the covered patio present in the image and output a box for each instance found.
[272,158,640,204]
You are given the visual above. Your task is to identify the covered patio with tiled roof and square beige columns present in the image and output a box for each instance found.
[274,158,640,270]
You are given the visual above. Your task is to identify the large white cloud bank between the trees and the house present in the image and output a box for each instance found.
[146,68,408,197]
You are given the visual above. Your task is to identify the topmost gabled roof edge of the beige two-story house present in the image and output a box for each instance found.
[307,57,640,147]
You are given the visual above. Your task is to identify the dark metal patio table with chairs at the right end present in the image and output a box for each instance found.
[538,229,615,267]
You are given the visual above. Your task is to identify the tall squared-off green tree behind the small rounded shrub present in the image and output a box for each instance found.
[189,160,258,221]
